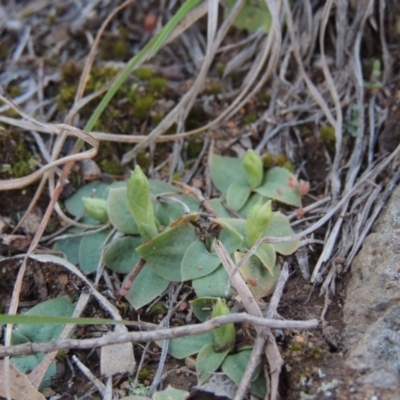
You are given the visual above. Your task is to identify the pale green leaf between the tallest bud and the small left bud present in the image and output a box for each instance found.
[107,187,139,235]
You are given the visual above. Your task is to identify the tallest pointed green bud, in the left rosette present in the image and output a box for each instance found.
[127,165,158,240]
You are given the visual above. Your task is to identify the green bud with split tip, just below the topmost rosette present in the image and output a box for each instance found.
[246,199,272,247]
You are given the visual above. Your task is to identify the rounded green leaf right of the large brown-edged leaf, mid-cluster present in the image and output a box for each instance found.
[181,240,221,281]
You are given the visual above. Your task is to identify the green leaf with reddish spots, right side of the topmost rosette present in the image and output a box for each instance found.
[254,167,301,207]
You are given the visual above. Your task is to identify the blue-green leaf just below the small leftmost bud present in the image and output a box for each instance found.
[79,230,110,274]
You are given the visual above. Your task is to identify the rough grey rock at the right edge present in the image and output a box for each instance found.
[343,187,400,399]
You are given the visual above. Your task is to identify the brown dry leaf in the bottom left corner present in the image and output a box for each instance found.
[0,360,45,400]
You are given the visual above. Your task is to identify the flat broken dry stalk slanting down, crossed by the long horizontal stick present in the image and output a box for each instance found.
[214,241,283,400]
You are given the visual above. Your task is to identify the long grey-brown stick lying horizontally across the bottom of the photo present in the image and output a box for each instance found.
[0,313,318,358]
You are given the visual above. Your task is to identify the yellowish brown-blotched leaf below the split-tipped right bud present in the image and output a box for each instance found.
[235,252,280,300]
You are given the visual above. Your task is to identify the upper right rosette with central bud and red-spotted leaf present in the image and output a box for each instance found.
[210,150,301,216]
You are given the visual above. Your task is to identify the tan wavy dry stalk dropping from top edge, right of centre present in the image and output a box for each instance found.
[319,0,343,200]
